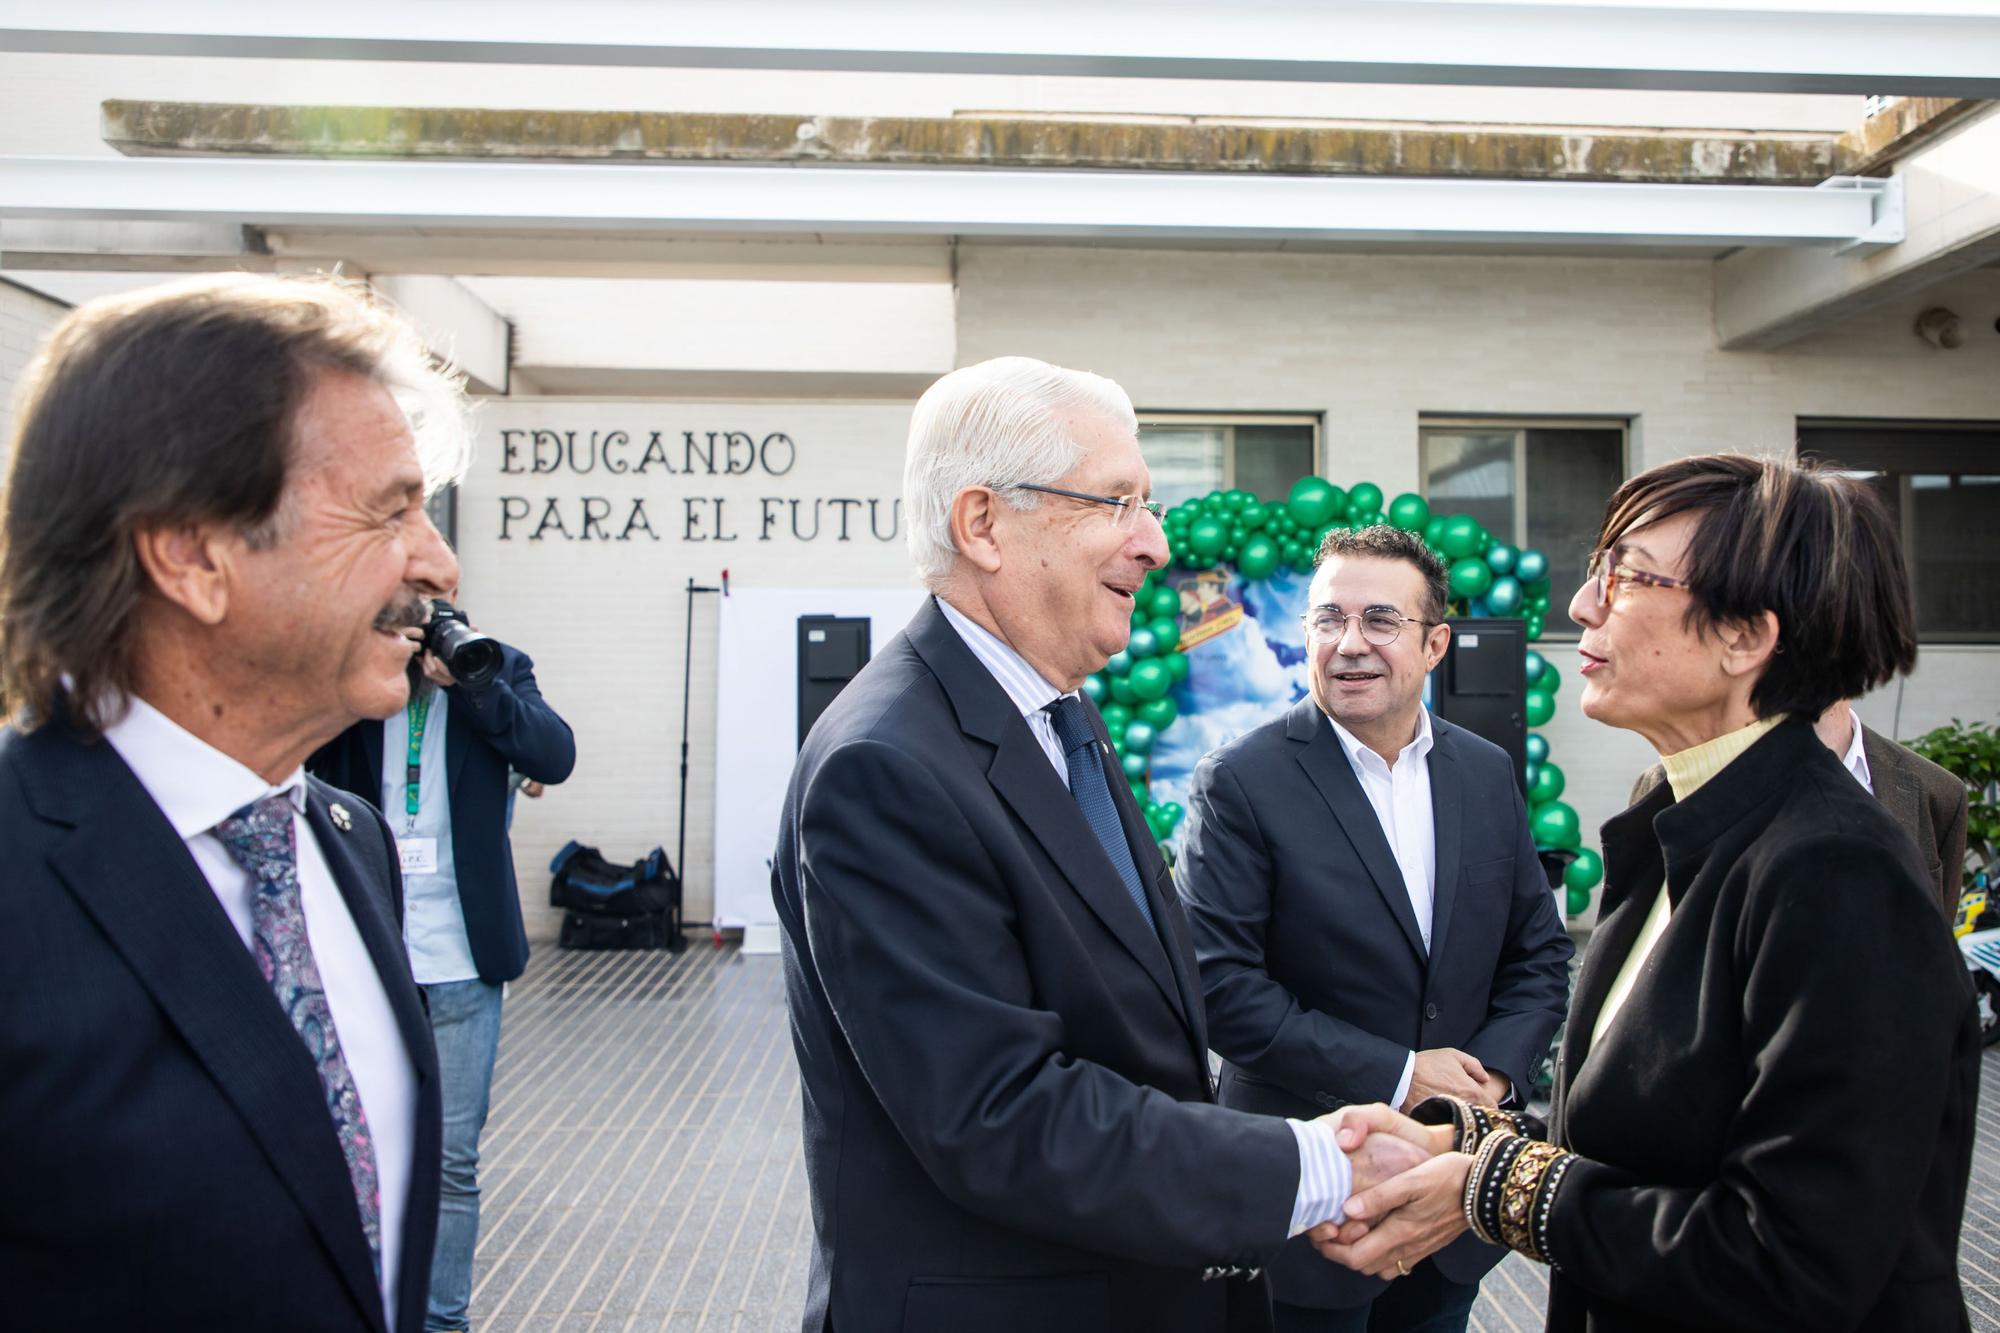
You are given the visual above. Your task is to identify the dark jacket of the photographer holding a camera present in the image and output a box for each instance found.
[306,644,576,985]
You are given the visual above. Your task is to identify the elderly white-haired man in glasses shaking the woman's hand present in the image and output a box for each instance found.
[774,356,1440,1333]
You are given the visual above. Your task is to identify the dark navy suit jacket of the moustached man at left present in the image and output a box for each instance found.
[0,700,440,1333]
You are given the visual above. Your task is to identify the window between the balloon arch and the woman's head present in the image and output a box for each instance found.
[1418,416,1632,638]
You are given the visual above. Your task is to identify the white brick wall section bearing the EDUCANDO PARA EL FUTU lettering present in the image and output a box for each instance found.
[458,398,914,939]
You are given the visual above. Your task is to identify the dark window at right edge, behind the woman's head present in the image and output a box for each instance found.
[1798,420,2000,642]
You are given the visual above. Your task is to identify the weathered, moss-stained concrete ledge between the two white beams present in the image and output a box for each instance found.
[104,100,1840,184]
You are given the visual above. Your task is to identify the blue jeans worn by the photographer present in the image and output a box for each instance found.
[424,977,500,1333]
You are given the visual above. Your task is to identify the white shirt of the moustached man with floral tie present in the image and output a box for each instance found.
[104,699,416,1333]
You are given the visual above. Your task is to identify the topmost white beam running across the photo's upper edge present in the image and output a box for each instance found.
[0,0,2000,98]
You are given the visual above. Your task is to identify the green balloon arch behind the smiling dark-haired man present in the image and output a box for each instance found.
[1084,476,1604,917]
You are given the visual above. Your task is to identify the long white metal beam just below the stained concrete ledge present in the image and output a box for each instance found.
[0,156,1902,248]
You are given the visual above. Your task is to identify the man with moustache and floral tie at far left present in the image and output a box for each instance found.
[0,274,466,1333]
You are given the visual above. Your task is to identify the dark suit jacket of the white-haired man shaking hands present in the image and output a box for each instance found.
[772,602,1298,1333]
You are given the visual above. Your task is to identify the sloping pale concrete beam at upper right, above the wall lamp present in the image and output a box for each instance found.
[1714,112,2000,350]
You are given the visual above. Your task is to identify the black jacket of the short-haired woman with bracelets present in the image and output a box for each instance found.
[1548,721,1980,1333]
